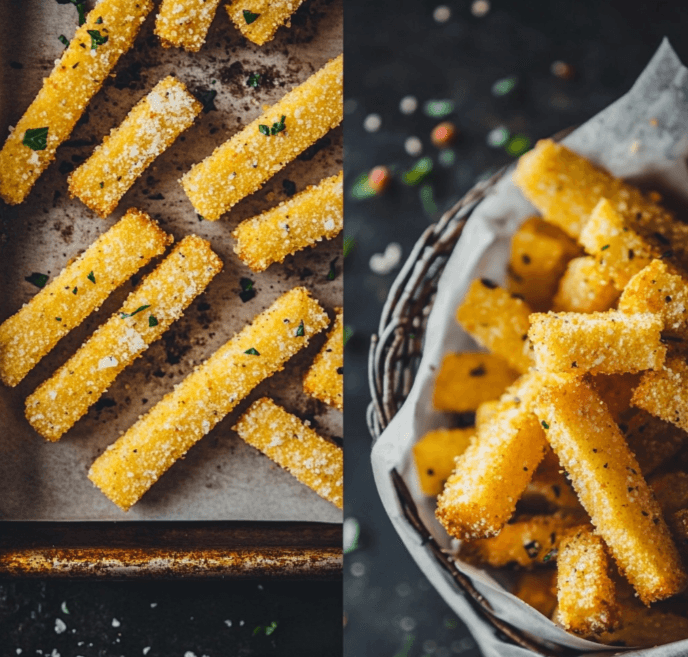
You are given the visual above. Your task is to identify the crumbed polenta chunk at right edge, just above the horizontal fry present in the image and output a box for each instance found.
[619,260,688,340]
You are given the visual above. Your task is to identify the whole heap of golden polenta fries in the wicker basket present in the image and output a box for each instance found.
[414,140,688,645]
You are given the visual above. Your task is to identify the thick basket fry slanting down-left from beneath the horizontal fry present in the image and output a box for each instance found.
[436,372,547,540]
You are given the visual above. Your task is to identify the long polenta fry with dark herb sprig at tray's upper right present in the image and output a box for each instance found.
[181,55,344,221]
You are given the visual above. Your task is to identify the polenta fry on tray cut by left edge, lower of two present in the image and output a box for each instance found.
[0,208,172,386]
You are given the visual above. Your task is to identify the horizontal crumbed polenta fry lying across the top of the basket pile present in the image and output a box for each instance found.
[528,310,666,374]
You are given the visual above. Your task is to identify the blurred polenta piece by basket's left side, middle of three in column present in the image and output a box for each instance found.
[432,352,518,413]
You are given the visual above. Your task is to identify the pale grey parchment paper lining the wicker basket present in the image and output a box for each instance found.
[372,40,688,657]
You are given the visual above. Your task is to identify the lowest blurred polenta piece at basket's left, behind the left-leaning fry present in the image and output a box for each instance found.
[413,427,475,497]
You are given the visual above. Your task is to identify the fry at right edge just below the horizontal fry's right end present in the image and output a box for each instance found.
[631,358,688,431]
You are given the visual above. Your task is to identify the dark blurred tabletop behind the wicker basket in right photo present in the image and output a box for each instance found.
[344,0,688,657]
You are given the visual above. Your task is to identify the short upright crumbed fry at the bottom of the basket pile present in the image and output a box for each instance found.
[557,528,619,636]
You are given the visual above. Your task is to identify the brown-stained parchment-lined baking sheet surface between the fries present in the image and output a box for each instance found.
[0,0,343,522]
